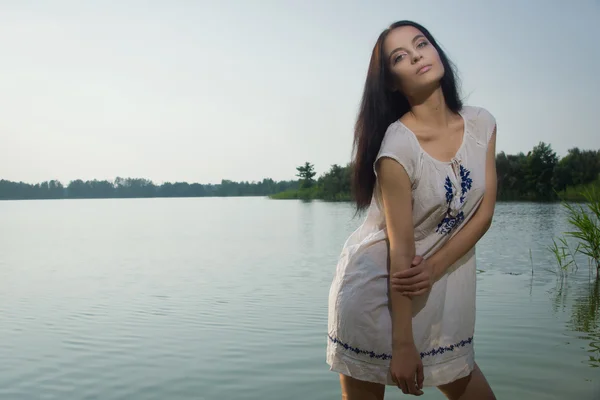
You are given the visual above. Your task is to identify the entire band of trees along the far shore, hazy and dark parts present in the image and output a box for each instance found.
[0,142,600,201]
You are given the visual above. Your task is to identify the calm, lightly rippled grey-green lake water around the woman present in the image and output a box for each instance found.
[0,198,600,400]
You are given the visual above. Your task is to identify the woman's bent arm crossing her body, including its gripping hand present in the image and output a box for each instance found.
[391,127,497,296]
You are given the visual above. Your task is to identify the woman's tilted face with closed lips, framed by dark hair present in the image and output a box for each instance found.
[383,26,445,97]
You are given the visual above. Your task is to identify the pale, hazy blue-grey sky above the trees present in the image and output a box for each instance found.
[0,0,600,183]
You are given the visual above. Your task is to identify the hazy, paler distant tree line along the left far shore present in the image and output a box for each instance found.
[0,178,299,200]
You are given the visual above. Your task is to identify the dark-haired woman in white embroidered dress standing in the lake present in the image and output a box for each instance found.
[327,21,496,400]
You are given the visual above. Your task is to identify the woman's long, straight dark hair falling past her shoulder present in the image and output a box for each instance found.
[352,21,462,211]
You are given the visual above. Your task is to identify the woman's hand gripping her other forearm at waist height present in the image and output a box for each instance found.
[391,256,436,297]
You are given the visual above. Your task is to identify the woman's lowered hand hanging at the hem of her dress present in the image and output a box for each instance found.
[390,343,424,396]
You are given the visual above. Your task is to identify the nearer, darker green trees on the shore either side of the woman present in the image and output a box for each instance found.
[271,142,600,201]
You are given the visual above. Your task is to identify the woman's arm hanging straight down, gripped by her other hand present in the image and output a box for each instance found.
[377,157,423,394]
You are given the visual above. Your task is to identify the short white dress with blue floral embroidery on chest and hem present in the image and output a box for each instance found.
[327,106,496,386]
